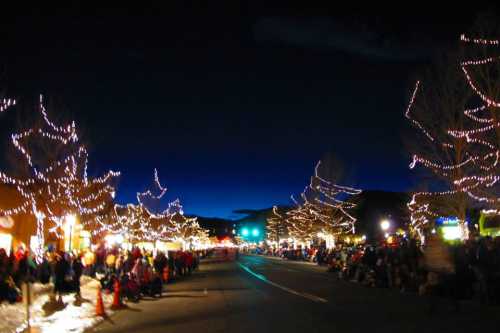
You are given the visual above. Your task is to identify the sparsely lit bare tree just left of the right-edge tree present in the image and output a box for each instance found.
[405,49,472,239]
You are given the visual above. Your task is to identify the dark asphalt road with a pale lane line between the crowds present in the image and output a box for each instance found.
[92,256,500,333]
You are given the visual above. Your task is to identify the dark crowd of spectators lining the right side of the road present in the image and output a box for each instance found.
[264,236,500,305]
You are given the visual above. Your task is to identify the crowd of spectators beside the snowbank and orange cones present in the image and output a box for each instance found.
[0,245,205,303]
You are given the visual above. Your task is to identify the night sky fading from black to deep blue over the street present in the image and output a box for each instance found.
[0,2,498,217]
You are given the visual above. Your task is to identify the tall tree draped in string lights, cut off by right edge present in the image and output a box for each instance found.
[458,34,500,210]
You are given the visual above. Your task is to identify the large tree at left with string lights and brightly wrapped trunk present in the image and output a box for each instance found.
[0,97,119,259]
